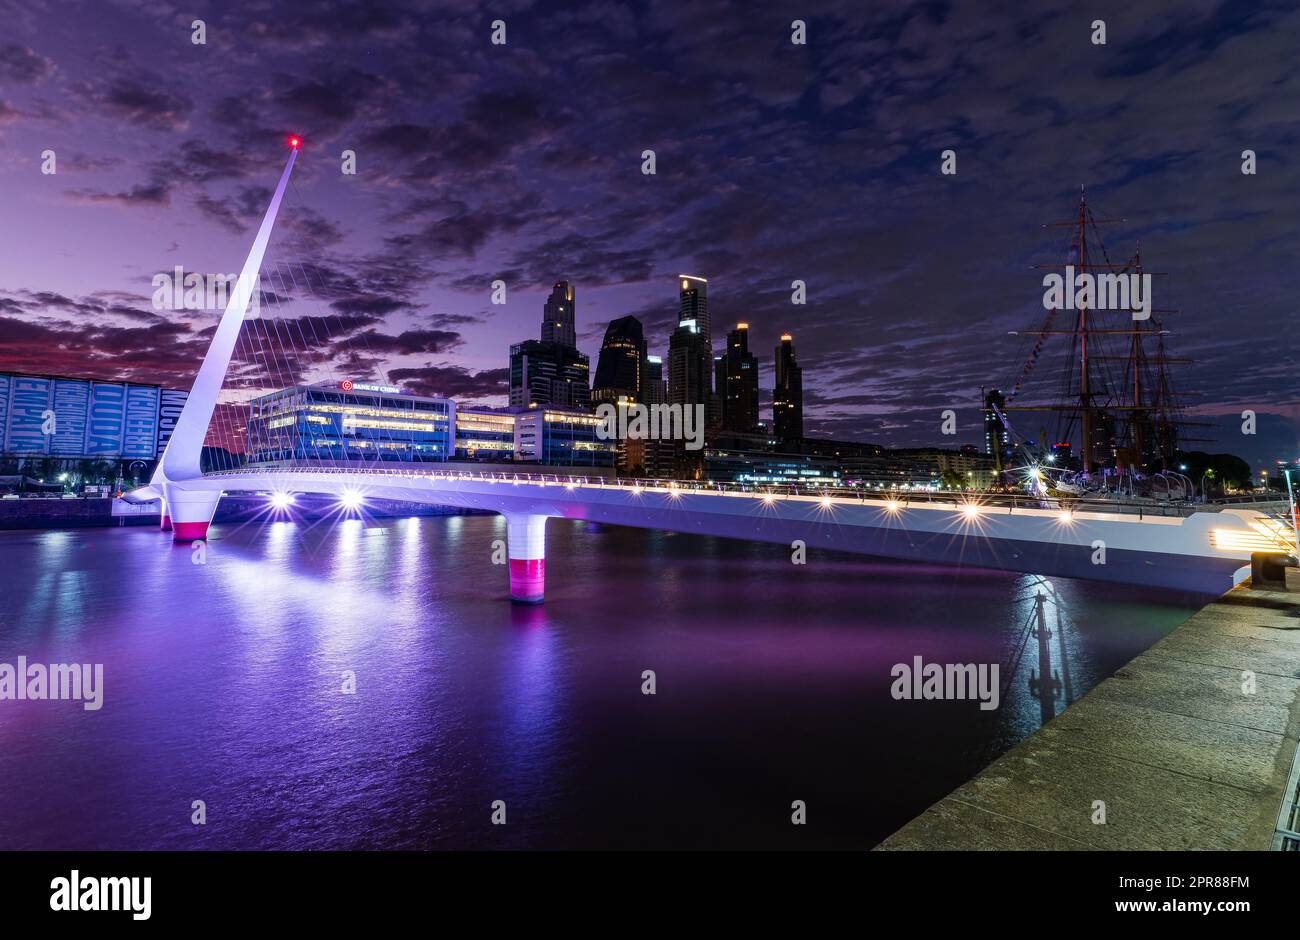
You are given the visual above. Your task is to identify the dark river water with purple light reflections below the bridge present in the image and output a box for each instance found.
[0,516,1199,849]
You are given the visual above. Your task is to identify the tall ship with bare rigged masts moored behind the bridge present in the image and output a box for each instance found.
[984,191,1204,499]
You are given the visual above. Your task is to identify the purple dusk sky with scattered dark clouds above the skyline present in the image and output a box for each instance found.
[0,0,1300,463]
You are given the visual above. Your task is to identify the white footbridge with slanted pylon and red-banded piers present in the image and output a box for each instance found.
[124,144,1284,602]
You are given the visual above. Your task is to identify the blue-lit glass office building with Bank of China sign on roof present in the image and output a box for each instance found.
[248,380,456,463]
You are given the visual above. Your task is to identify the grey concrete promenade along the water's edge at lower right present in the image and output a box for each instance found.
[878,569,1300,850]
